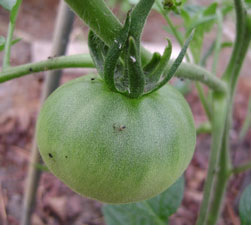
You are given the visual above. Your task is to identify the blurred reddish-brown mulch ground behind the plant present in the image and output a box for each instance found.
[0,0,251,225]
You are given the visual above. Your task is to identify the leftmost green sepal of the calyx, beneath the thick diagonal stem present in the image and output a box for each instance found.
[88,30,108,78]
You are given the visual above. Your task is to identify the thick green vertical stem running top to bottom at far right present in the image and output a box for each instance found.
[197,0,251,225]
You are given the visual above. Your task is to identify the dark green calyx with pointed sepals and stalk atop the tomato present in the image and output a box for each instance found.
[88,0,192,98]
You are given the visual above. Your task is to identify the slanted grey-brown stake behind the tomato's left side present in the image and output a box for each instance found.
[21,1,74,225]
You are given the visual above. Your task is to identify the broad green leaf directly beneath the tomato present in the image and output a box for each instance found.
[102,176,184,225]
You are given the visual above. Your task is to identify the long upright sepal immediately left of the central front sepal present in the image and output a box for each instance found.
[104,12,131,91]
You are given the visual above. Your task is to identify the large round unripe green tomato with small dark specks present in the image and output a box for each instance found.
[37,76,196,203]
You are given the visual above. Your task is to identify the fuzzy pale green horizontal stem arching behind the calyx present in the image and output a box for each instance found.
[0,54,227,93]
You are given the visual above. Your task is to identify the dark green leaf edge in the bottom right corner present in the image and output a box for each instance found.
[239,184,251,225]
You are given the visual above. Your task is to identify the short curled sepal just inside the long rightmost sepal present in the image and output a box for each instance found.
[149,39,172,82]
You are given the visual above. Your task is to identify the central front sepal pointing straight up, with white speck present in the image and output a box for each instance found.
[127,37,145,98]
